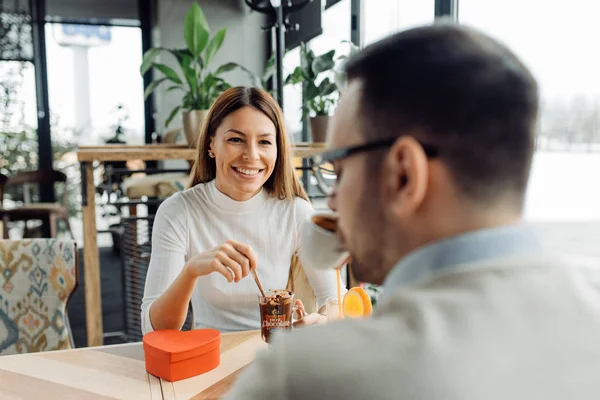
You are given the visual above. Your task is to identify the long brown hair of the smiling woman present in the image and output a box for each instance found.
[188,86,308,201]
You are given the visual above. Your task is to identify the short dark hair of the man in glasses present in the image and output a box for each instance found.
[345,23,539,207]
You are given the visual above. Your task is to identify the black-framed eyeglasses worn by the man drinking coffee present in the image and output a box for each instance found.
[309,138,439,195]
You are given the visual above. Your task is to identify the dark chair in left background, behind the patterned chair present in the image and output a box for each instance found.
[0,170,74,238]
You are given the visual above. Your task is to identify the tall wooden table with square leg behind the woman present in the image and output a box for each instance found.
[77,143,324,346]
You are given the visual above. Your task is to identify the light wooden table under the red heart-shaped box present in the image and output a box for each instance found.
[0,331,267,400]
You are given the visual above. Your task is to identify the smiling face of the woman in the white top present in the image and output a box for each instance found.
[209,106,277,201]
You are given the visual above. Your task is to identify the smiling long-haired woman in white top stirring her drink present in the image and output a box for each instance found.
[142,87,344,333]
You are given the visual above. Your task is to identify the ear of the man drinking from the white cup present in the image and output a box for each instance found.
[381,136,429,217]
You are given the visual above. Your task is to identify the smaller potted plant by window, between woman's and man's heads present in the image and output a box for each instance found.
[285,41,357,142]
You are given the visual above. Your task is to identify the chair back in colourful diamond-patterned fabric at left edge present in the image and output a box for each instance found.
[0,239,77,355]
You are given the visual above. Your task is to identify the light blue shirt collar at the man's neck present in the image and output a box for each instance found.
[379,223,542,302]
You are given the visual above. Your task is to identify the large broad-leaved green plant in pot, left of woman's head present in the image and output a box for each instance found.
[140,1,247,145]
